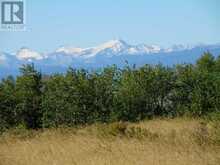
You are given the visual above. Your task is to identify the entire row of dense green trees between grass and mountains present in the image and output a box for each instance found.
[0,53,220,130]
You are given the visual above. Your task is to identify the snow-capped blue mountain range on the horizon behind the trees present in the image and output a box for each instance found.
[0,40,220,77]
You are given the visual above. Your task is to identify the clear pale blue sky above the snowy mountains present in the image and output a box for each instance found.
[0,0,220,52]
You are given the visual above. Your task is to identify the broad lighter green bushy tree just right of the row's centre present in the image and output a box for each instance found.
[117,65,174,121]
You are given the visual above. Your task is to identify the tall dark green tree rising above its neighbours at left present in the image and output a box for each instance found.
[16,64,42,129]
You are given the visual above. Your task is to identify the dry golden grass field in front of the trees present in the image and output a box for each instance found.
[0,119,220,165]
